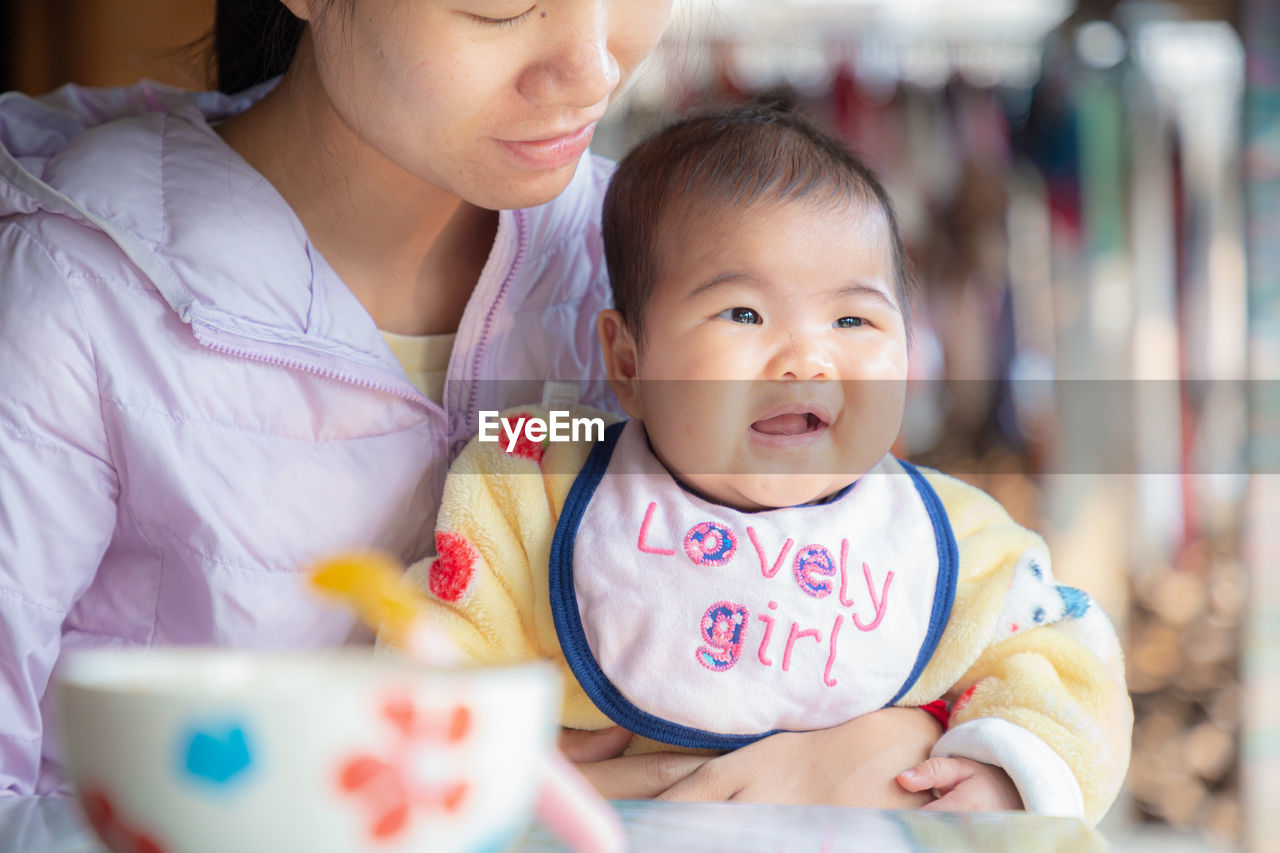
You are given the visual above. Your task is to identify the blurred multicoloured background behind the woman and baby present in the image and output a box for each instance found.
[0,0,1280,850]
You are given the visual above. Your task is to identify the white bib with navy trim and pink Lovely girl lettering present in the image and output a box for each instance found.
[550,421,956,749]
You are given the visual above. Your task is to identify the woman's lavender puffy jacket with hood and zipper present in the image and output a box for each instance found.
[0,83,612,794]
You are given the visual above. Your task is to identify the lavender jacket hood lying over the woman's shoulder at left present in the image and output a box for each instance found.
[0,82,399,377]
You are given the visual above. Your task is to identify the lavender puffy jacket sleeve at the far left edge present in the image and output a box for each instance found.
[0,222,119,795]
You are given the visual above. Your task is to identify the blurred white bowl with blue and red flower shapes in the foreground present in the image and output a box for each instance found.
[56,648,559,853]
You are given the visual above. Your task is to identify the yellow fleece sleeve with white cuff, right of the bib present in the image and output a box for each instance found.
[902,473,1133,822]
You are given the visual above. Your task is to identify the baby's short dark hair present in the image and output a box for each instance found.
[603,105,910,343]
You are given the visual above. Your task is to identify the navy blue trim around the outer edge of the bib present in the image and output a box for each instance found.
[548,421,959,751]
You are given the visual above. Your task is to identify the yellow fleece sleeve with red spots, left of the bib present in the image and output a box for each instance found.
[410,409,613,729]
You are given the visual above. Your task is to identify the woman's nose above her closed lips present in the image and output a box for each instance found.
[520,0,622,110]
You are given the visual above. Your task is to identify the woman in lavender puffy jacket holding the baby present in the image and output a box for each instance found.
[0,0,938,806]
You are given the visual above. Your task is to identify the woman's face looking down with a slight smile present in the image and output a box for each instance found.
[298,0,671,209]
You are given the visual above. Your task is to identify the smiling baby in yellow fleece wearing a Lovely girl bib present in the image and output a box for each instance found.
[425,108,1132,821]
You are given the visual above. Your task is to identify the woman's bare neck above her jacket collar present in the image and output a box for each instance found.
[218,36,498,334]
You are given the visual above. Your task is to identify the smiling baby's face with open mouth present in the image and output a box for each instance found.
[602,195,908,510]
